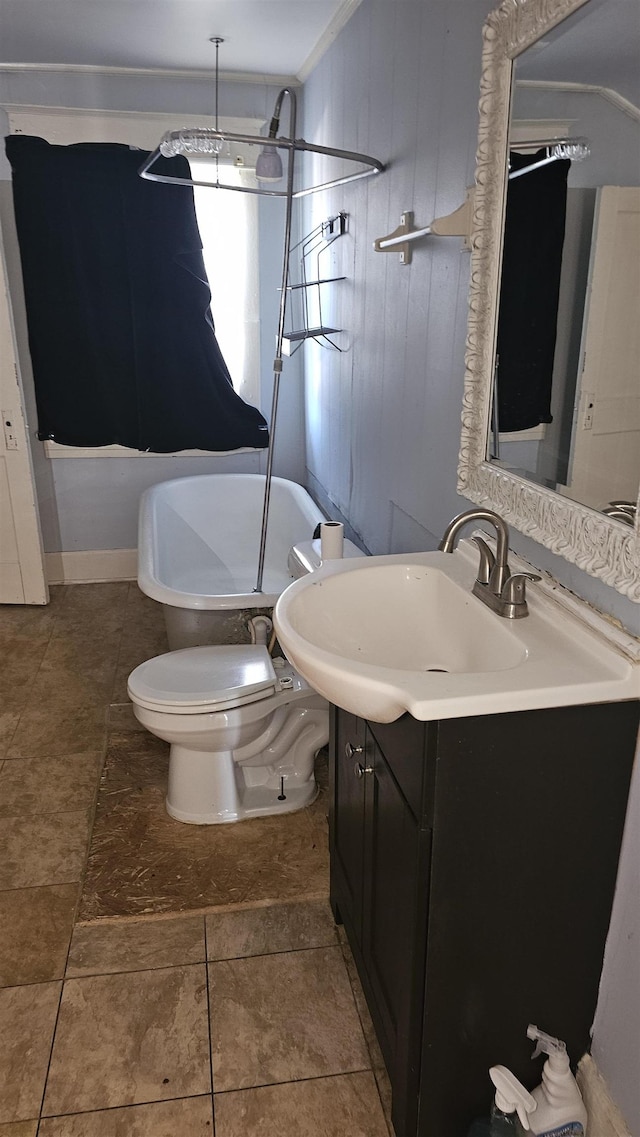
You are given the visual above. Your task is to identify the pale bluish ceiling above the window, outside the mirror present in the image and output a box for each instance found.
[0,0,359,78]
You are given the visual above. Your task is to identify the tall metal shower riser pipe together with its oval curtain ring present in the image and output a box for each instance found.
[138,86,384,592]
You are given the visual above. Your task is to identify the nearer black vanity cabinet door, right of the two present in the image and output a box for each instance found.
[363,730,431,1137]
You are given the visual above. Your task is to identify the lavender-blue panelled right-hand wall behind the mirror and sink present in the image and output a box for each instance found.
[304,0,640,1132]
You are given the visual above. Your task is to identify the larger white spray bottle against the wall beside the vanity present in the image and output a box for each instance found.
[526,1023,587,1137]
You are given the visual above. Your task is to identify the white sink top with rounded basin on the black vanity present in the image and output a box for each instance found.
[274,541,640,722]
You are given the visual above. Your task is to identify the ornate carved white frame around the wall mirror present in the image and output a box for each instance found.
[458,0,640,603]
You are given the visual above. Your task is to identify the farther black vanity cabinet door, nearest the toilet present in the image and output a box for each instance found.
[329,711,366,946]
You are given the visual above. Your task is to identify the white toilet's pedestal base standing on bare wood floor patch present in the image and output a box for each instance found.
[165,744,318,825]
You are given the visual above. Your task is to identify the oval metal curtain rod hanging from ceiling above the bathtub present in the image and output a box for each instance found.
[138,133,385,198]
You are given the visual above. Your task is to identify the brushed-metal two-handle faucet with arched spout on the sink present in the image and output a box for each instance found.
[438,509,541,620]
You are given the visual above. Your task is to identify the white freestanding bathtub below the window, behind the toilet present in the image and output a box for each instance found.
[138,474,325,650]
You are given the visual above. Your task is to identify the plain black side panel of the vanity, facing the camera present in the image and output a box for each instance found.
[418,703,638,1137]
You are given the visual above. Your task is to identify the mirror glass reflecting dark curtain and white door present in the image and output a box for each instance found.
[488,0,640,524]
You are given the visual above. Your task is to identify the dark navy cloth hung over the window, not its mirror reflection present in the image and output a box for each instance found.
[7,135,268,453]
